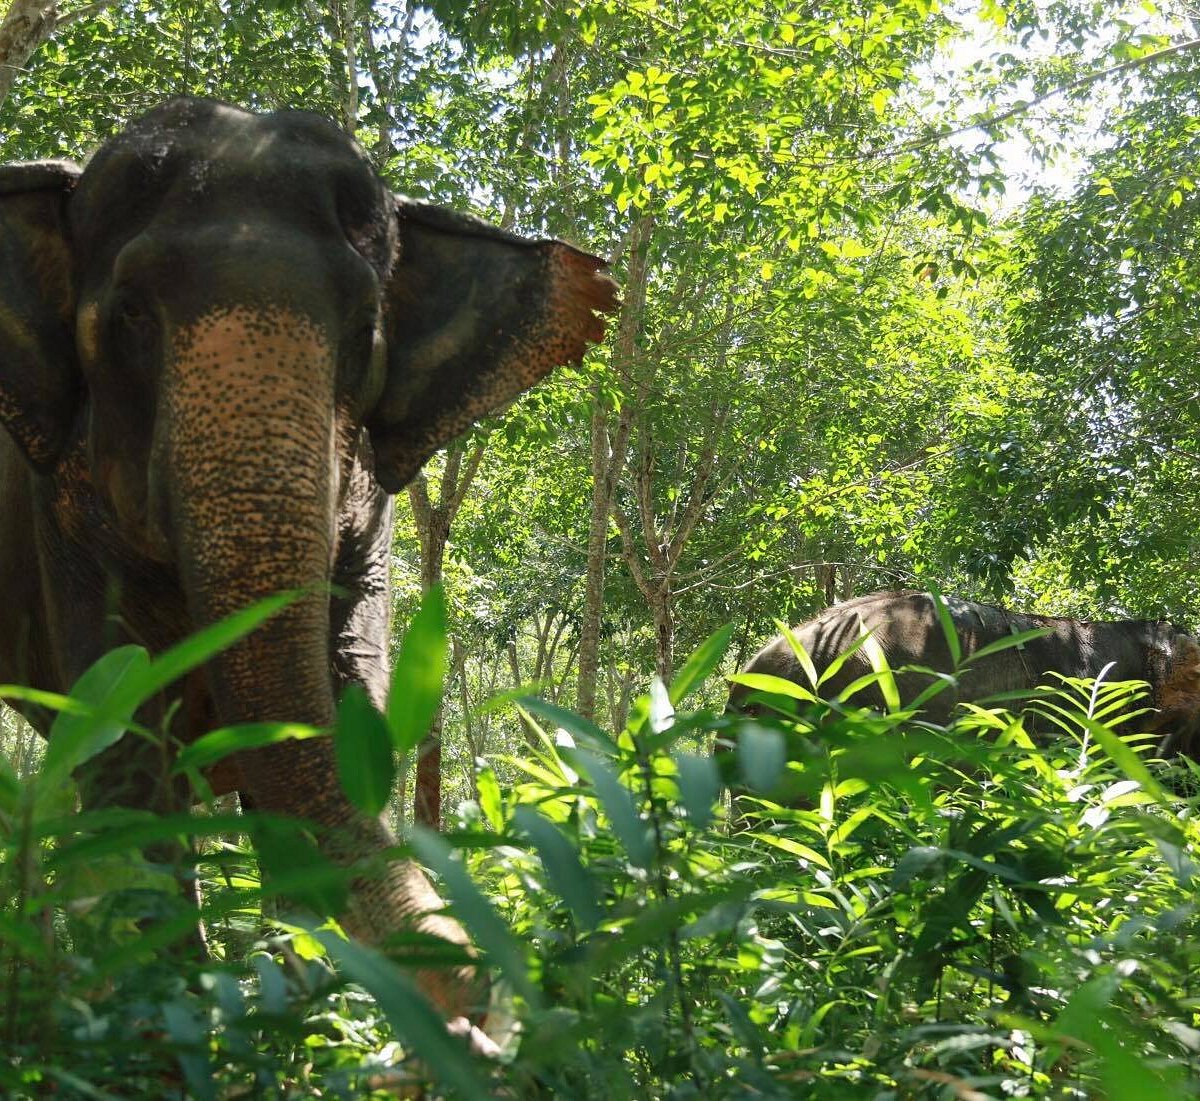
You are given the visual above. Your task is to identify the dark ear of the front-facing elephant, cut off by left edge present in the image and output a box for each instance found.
[0,161,80,470]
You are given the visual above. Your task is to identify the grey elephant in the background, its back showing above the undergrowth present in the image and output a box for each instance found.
[727,589,1200,756]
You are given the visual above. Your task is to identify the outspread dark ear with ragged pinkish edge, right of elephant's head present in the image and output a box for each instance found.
[367,197,617,493]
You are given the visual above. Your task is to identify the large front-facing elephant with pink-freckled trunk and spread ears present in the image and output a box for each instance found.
[0,98,616,1016]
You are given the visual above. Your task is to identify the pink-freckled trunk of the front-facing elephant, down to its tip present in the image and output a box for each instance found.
[165,306,476,1016]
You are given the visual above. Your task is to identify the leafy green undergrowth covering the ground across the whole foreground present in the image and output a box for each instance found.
[0,599,1200,1101]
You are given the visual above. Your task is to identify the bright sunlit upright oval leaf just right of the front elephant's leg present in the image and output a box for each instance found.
[388,585,446,756]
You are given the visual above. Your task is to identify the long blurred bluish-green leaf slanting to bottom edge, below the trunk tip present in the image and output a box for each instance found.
[313,929,492,1097]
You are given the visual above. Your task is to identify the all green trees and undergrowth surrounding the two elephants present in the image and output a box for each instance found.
[0,0,1200,1101]
